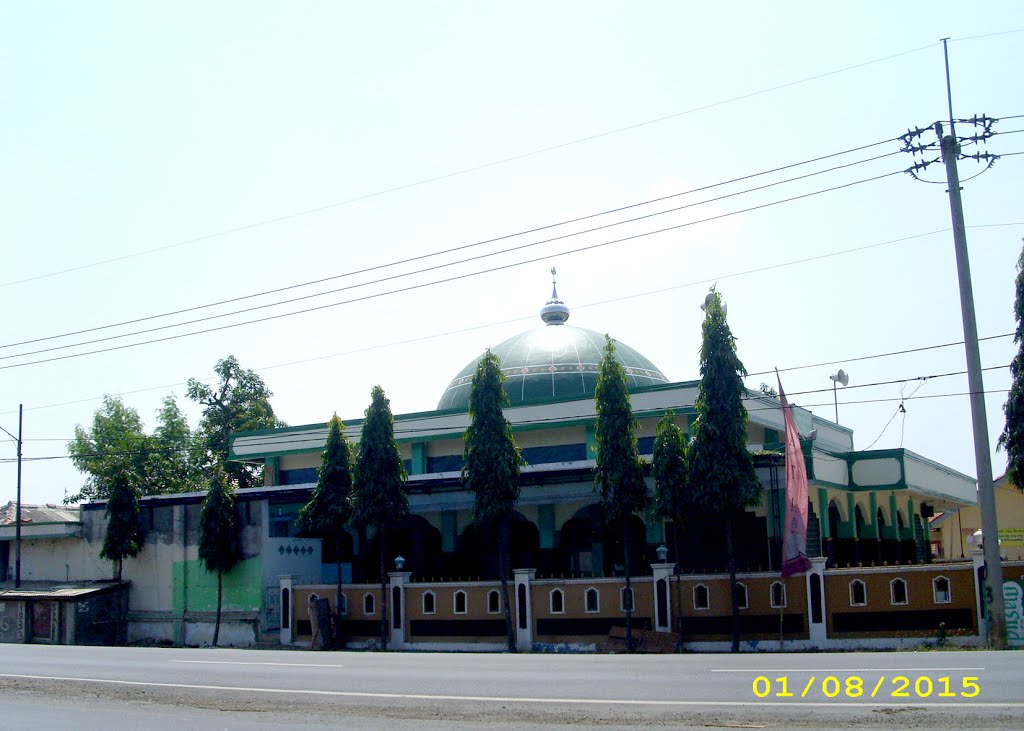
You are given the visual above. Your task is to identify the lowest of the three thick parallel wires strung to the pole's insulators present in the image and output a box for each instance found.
[0,170,904,371]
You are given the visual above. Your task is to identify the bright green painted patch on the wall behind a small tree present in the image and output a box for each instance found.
[171,556,263,614]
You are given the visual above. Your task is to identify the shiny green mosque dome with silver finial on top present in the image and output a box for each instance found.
[437,272,669,411]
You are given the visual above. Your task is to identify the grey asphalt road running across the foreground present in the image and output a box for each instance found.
[0,645,1024,729]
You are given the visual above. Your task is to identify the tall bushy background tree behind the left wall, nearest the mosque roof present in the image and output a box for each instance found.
[186,355,285,488]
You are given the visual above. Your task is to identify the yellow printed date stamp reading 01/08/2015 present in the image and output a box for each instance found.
[752,672,981,699]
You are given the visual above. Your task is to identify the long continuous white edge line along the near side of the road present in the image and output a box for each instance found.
[0,673,1024,711]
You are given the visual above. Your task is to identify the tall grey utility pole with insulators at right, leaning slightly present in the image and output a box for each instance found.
[900,39,1007,650]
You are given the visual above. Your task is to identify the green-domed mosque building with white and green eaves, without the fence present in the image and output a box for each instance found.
[230,274,974,593]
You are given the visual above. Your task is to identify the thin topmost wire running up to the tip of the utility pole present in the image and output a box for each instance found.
[0,39,942,288]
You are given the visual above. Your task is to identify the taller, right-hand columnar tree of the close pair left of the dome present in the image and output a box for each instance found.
[352,386,409,650]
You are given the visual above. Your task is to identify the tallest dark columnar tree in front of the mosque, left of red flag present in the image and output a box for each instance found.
[689,289,761,652]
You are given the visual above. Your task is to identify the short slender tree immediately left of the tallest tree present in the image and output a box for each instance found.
[653,409,696,641]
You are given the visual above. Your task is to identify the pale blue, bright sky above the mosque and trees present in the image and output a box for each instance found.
[0,2,1024,502]
